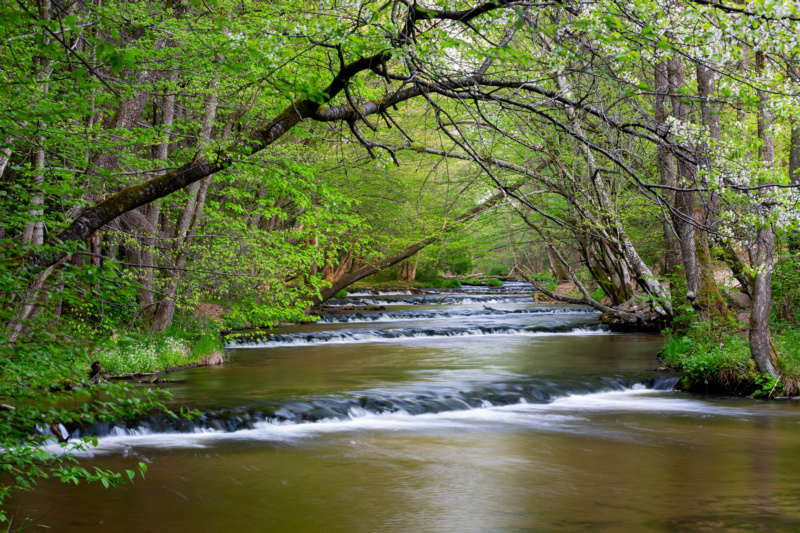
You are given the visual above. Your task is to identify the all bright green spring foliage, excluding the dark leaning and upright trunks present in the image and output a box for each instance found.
[0,0,800,516]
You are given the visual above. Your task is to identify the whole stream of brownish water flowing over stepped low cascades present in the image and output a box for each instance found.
[14,284,800,533]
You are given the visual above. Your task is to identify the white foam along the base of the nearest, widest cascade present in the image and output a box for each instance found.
[48,385,768,455]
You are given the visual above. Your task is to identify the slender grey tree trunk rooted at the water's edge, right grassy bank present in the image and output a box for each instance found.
[750,51,779,377]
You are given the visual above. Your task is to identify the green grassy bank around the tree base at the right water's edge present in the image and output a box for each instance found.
[660,323,800,398]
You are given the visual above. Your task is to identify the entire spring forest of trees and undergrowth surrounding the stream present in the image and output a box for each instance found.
[0,0,800,520]
